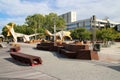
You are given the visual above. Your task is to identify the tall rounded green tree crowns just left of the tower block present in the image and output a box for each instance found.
[25,13,65,32]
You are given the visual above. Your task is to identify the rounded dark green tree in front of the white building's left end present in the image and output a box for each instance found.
[71,28,91,40]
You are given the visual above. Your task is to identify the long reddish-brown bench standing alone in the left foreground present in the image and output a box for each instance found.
[10,52,42,66]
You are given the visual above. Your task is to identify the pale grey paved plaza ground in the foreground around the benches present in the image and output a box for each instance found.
[0,43,120,80]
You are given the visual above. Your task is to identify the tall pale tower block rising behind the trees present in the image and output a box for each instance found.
[59,11,76,23]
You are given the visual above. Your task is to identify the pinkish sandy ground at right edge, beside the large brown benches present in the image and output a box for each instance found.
[98,42,120,63]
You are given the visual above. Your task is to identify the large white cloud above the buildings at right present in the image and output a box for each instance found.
[57,0,120,22]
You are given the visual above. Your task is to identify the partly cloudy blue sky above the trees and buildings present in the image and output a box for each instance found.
[0,0,120,32]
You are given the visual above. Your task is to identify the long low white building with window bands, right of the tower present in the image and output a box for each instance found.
[66,15,120,30]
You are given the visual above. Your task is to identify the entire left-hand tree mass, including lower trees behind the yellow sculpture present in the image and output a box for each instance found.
[2,13,65,37]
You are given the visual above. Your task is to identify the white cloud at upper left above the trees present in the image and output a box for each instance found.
[0,0,50,16]
